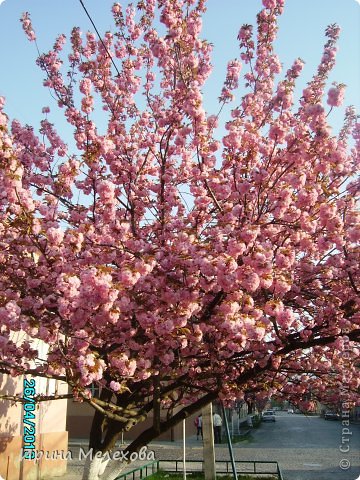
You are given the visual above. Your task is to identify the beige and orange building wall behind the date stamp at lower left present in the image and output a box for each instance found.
[0,338,68,480]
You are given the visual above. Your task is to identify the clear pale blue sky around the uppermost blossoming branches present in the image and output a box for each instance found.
[0,0,360,135]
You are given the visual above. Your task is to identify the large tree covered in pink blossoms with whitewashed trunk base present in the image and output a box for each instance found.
[0,0,360,480]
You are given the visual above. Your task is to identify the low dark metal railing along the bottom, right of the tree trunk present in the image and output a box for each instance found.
[116,460,283,480]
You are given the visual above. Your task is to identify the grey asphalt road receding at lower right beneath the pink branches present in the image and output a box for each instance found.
[235,412,360,480]
